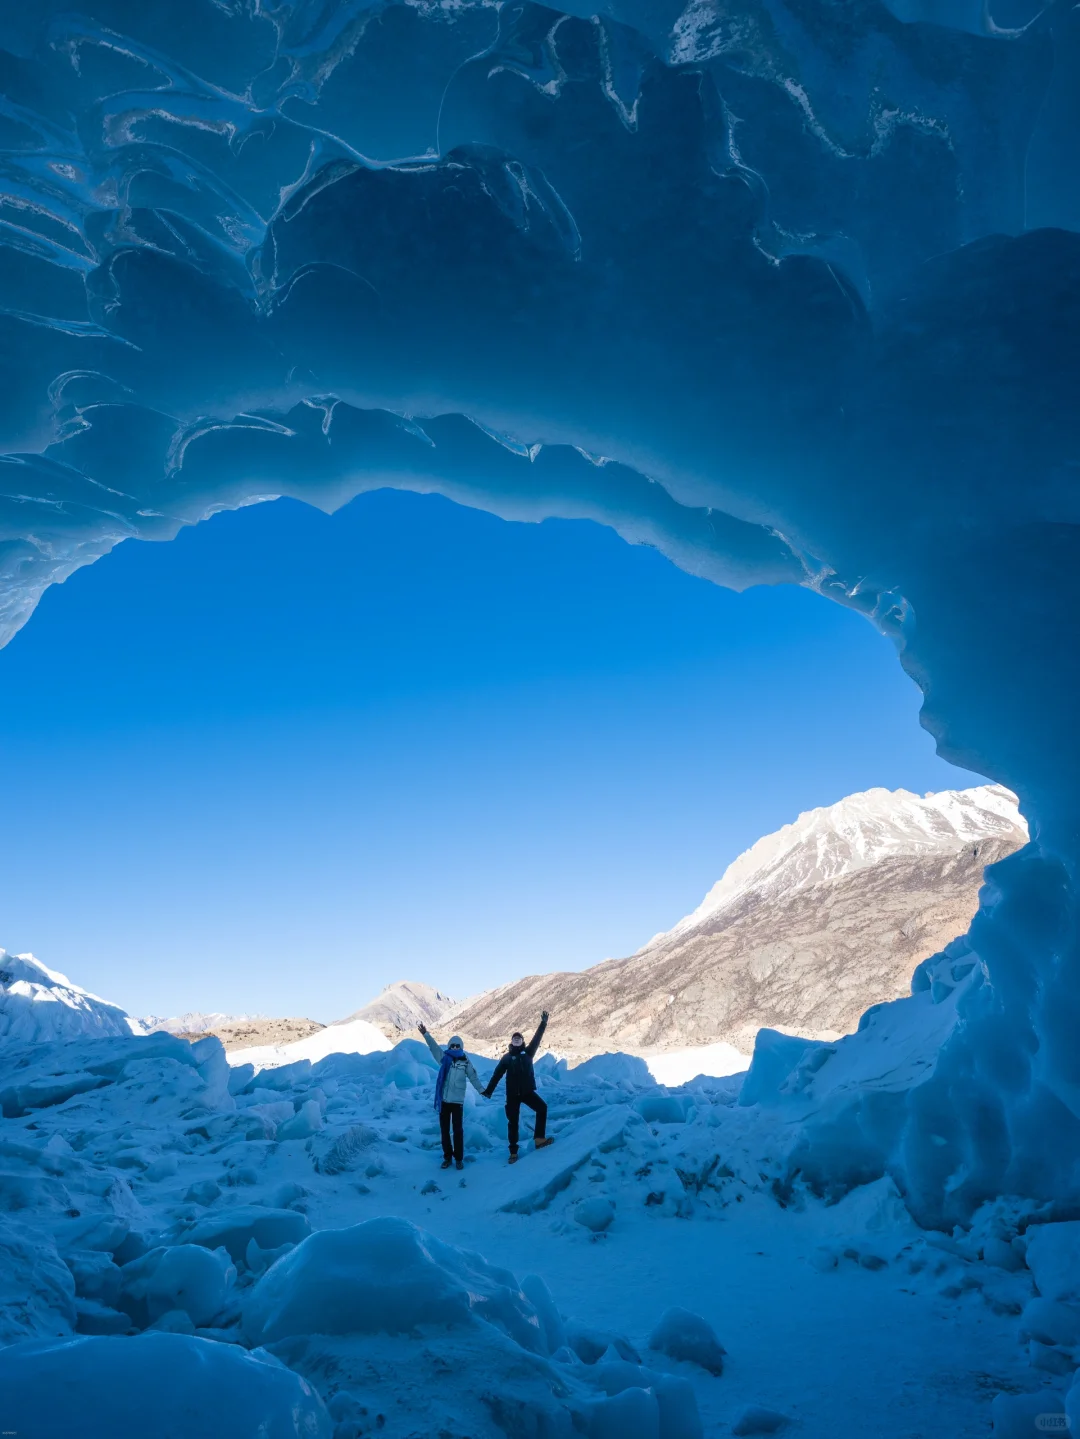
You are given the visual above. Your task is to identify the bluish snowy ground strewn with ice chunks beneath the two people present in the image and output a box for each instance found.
[0,1033,1080,1439]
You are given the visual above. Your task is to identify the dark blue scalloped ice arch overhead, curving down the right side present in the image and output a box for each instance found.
[0,0,1080,1215]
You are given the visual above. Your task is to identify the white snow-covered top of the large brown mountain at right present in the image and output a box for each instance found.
[644,784,1027,950]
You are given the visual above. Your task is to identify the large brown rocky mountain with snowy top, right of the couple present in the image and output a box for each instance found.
[454,786,1027,1055]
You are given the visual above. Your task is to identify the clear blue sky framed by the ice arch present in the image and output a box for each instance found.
[0,491,978,1020]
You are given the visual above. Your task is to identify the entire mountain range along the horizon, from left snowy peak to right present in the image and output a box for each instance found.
[0,786,1027,1063]
